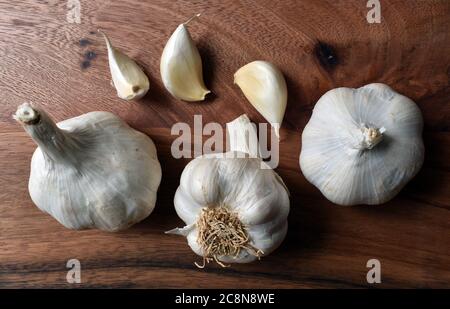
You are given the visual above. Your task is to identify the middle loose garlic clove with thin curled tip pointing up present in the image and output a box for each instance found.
[160,14,210,102]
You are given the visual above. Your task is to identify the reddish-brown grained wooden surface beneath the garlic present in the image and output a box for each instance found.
[0,0,450,288]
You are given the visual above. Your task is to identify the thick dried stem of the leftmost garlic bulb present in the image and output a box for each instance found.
[14,103,83,166]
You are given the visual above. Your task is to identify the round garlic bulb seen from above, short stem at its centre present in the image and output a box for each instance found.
[300,84,424,205]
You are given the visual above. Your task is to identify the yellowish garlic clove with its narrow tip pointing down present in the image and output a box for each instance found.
[234,61,287,138]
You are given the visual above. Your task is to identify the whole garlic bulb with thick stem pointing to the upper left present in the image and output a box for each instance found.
[14,103,161,231]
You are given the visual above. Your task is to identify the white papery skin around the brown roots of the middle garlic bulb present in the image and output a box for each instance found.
[168,115,289,263]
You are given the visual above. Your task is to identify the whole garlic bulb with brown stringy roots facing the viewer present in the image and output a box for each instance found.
[168,115,289,267]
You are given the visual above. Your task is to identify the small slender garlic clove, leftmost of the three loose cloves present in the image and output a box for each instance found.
[99,30,150,100]
